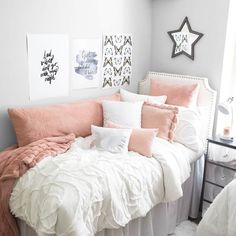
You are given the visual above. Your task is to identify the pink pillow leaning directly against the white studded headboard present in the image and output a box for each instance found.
[150,79,199,107]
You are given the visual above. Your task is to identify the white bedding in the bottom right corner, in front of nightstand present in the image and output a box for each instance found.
[197,180,236,236]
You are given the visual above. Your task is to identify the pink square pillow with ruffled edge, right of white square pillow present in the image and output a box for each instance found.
[142,103,178,142]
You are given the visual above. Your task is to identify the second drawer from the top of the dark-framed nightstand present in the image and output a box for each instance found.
[205,162,235,187]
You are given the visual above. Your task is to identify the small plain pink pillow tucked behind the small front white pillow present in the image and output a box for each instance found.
[107,121,158,157]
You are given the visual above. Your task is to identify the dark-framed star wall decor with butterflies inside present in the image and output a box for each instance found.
[168,17,203,60]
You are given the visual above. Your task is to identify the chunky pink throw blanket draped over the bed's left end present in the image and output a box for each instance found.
[0,134,75,236]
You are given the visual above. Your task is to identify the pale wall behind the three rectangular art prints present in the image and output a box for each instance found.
[0,0,152,149]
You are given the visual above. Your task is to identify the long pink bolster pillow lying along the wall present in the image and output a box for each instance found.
[8,94,120,147]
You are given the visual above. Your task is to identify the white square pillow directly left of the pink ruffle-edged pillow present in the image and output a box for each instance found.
[102,101,143,128]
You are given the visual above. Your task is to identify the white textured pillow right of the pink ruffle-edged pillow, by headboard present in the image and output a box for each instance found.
[174,107,203,152]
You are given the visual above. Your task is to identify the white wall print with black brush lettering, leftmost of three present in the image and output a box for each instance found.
[27,34,69,100]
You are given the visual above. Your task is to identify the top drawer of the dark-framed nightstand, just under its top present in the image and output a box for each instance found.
[208,143,236,162]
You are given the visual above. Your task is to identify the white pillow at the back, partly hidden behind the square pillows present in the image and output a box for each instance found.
[120,89,167,104]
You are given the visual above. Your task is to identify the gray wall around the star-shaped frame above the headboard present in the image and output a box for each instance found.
[151,0,229,93]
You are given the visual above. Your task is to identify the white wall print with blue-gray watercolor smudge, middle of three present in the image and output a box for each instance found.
[72,39,102,89]
